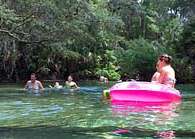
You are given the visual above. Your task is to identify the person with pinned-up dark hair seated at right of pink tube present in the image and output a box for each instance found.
[157,54,176,87]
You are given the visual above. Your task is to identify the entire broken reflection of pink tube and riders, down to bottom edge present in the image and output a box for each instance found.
[110,101,180,139]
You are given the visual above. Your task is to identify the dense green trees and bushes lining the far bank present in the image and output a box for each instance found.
[0,0,195,82]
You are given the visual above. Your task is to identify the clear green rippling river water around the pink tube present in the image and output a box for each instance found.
[0,83,195,139]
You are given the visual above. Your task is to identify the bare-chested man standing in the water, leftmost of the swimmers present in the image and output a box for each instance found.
[25,73,44,90]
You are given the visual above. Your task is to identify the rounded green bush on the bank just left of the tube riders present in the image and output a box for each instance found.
[119,38,163,80]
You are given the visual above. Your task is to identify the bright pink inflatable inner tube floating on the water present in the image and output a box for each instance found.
[110,81,181,103]
